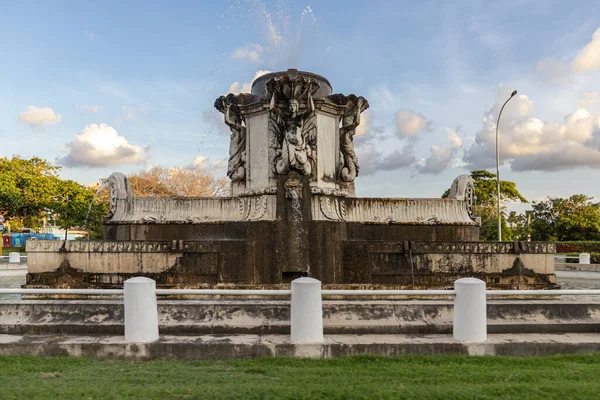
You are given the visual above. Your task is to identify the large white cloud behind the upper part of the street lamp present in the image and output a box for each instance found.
[465,88,600,171]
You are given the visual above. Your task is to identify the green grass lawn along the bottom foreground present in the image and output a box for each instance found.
[0,355,600,399]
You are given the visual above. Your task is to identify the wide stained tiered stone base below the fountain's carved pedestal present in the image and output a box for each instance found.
[27,174,555,289]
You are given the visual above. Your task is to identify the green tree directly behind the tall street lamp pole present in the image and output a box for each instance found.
[442,170,528,241]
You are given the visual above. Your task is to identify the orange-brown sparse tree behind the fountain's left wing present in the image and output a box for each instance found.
[128,166,227,197]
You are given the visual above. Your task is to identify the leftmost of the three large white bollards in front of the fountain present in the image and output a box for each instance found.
[123,277,158,343]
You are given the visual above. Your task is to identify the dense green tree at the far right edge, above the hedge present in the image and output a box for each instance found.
[531,194,600,241]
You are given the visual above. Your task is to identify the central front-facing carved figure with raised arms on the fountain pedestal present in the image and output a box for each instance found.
[266,75,319,176]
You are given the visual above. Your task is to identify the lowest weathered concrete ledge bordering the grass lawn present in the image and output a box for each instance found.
[0,333,600,360]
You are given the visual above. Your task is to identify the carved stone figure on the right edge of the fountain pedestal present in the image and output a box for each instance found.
[340,94,369,182]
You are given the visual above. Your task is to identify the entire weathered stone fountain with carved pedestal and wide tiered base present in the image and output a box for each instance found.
[27,70,555,289]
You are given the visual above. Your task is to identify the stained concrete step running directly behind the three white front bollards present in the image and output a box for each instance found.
[0,299,600,335]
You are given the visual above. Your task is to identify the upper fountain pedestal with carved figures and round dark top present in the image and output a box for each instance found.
[215,70,368,196]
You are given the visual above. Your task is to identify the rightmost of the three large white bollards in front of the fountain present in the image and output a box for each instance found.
[453,278,487,342]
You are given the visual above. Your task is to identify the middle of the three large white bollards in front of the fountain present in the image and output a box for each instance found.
[291,278,323,343]
